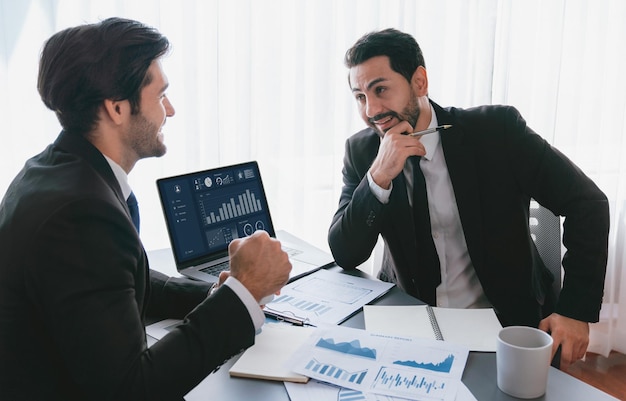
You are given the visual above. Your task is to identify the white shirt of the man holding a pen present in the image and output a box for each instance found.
[367,106,491,308]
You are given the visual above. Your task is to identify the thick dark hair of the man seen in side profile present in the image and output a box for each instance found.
[37,18,169,135]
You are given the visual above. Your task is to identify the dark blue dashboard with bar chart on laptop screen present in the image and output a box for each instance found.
[157,162,274,268]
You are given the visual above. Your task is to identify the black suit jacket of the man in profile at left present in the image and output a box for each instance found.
[0,133,254,401]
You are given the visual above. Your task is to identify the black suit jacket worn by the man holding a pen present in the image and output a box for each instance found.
[328,103,609,326]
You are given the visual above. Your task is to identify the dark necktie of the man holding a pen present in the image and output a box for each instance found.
[411,156,441,306]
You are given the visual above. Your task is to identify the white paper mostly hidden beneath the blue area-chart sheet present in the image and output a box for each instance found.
[285,380,478,401]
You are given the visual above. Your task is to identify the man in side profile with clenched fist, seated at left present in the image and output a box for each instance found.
[0,18,291,401]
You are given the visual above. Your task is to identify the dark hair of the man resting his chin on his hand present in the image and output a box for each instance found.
[344,28,426,82]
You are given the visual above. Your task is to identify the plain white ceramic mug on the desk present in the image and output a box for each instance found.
[496,326,552,398]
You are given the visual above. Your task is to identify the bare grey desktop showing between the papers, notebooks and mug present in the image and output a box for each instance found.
[148,244,617,401]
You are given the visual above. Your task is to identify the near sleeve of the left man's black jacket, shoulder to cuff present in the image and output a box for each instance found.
[26,199,254,400]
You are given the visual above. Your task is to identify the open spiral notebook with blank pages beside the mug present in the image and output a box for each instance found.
[363,305,502,352]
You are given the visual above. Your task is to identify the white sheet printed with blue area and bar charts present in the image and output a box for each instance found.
[290,326,469,401]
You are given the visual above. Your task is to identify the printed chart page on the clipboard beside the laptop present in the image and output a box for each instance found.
[264,270,394,326]
